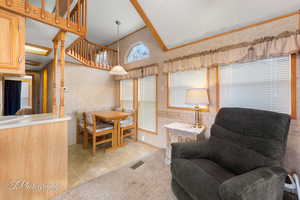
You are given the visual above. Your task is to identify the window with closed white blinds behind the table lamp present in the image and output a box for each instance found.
[168,68,207,109]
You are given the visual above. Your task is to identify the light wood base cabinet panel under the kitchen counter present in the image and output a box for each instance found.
[0,119,68,200]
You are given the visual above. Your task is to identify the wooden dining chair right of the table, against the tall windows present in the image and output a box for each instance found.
[120,109,137,143]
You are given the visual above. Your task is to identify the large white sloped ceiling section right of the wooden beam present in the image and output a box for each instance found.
[137,0,300,48]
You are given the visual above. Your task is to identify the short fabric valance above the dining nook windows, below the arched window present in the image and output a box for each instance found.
[116,64,158,80]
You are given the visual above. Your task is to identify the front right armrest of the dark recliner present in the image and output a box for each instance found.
[219,167,287,200]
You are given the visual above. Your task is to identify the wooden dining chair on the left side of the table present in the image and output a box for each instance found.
[84,112,114,156]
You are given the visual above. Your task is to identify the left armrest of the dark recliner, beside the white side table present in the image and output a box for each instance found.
[171,140,210,160]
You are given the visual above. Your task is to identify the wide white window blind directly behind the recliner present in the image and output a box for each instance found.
[219,57,291,114]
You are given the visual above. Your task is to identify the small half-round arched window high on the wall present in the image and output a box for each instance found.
[127,43,150,63]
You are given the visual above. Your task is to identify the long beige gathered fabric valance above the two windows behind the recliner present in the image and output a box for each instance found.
[163,30,300,73]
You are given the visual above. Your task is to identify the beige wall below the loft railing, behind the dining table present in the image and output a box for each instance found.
[65,63,116,145]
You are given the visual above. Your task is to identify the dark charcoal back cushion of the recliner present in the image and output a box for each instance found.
[210,108,290,174]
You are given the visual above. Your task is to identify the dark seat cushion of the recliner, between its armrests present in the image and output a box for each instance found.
[171,159,235,200]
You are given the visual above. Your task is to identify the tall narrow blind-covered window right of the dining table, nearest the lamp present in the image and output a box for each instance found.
[138,76,157,133]
